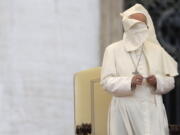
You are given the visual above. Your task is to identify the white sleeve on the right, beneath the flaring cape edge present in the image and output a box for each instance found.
[155,75,175,94]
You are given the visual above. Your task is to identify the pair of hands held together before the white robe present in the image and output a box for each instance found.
[131,75,157,88]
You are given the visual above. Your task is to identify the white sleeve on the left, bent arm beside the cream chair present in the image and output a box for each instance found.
[100,48,133,96]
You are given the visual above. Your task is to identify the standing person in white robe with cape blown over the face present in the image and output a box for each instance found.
[100,4,178,135]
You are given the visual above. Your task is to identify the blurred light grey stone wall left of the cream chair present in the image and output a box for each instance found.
[0,0,100,135]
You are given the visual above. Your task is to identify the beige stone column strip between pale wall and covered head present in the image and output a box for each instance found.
[100,0,124,61]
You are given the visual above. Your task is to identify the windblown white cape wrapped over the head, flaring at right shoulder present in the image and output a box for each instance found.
[120,4,178,76]
